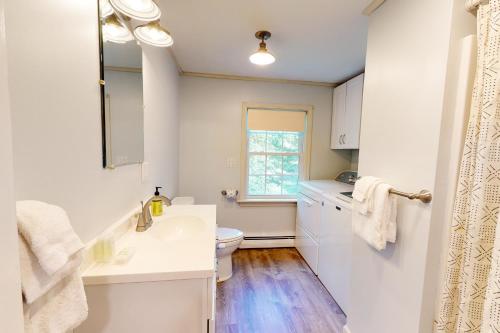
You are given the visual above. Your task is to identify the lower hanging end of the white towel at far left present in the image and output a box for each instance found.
[24,272,88,333]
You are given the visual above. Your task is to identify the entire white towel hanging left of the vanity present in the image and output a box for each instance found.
[17,201,88,333]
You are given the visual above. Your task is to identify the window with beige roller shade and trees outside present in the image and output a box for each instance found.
[242,105,312,201]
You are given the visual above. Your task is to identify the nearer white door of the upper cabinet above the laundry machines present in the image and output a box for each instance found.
[342,74,365,149]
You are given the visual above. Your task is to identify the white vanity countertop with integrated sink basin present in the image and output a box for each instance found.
[82,205,217,285]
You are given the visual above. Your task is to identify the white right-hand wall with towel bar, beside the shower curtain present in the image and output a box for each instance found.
[348,0,474,333]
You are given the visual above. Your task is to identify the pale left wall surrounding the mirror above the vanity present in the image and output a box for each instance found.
[7,0,178,241]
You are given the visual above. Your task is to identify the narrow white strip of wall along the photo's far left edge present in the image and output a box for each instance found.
[0,0,24,333]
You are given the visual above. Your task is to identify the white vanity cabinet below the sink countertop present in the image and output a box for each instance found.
[74,275,216,333]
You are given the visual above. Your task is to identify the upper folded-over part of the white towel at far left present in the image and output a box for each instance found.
[16,201,83,275]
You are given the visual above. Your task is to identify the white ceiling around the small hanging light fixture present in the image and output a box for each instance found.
[157,0,371,82]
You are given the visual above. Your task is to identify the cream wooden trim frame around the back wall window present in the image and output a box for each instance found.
[238,103,314,205]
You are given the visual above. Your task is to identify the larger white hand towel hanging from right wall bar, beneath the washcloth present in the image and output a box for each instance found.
[352,183,397,251]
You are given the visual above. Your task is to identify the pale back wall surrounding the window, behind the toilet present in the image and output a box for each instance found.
[179,77,351,236]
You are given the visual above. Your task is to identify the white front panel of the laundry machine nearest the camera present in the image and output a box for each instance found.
[318,200,352,314]
